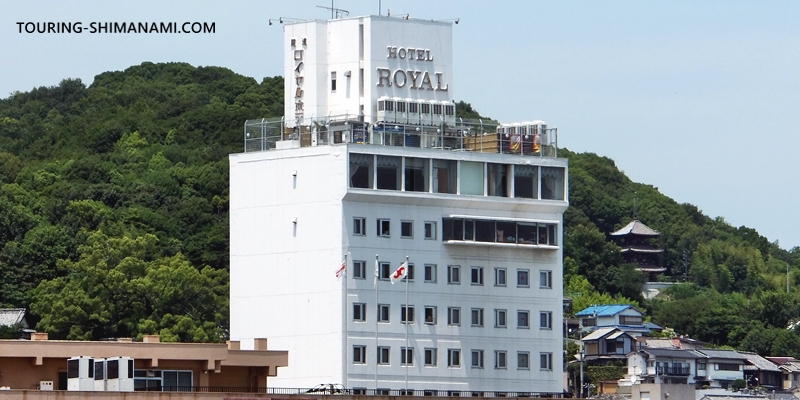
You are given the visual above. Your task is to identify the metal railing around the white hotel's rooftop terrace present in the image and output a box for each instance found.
[244,115,558,157]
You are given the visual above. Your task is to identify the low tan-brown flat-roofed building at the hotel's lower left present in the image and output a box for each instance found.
[0,333,289,392]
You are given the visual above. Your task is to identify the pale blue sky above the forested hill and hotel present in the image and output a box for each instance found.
[0,0,800,249]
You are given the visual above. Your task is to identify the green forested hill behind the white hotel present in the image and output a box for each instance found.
[0,63,800,356]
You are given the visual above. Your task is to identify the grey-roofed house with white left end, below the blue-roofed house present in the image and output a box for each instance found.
[622,348,703,384]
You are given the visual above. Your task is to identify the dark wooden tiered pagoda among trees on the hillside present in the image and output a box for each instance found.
[611,219,667,280]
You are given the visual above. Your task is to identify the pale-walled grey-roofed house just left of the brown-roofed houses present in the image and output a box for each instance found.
[692,349,747,389]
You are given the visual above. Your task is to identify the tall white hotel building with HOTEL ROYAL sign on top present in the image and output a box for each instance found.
[230,16,568,395]
